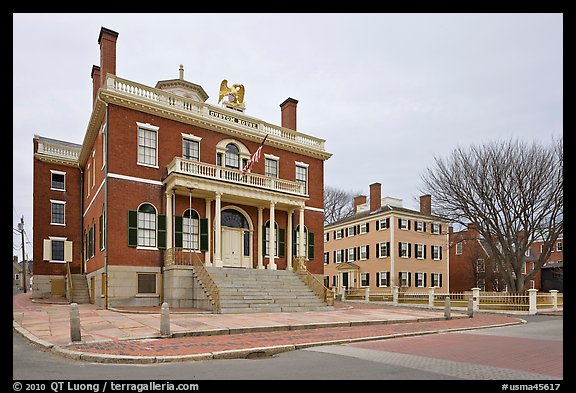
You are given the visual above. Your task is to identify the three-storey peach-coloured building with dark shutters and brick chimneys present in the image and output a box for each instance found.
[324,183,449,293]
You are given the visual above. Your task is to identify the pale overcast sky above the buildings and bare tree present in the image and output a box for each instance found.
[12,13,563,258]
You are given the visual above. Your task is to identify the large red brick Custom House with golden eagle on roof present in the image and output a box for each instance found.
[34,28,331,306]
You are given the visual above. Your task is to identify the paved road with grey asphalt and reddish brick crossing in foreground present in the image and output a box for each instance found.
[13,316,563,382]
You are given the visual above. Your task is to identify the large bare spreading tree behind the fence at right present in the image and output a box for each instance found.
[422,139,564,291]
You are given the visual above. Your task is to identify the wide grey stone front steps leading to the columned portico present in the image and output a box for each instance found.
[206,267,334,314]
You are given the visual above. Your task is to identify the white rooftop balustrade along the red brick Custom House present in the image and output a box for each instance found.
[103,75,325,151]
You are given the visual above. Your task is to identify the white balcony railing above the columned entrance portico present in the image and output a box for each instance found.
[168,157,307,196]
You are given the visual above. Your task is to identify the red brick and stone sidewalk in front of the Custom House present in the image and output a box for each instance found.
[13,294,522,363]
